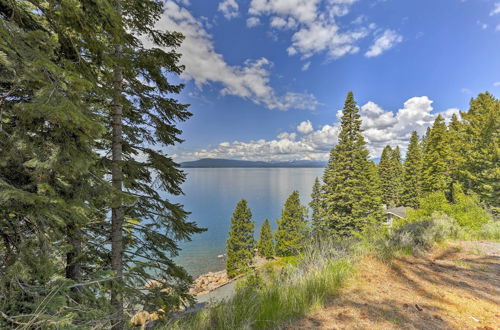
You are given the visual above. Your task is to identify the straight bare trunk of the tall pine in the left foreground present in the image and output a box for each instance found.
[111,0,124,330]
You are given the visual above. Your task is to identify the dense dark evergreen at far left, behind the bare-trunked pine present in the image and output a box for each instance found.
[0,1,109,328]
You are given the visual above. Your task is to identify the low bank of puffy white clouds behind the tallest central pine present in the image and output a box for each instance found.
[177,96,460,160]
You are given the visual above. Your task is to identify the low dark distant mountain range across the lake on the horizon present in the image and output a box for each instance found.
[181,158,326,168]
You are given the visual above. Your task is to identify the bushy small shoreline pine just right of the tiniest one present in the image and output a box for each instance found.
[275,191,307,257]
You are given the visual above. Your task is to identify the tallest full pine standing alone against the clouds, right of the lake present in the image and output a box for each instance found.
[323,92,382,235]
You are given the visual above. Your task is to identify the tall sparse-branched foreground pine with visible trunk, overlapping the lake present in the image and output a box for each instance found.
[92,0,203,328]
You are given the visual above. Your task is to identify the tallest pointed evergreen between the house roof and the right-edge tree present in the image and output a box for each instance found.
[422,115,451,194]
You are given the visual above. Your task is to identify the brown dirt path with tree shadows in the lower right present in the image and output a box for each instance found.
[288,242,500,330]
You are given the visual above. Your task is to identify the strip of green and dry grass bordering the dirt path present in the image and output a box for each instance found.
[163,213,500,329]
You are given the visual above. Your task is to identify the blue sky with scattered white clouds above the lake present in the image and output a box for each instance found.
[157,0,500,161]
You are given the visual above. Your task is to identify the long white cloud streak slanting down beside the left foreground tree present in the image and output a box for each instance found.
[150,0,318,110]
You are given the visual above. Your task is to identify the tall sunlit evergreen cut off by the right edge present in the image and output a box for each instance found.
[462,92,500,214]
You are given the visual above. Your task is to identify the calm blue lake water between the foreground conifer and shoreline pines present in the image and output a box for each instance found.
[176,168,323,276]
